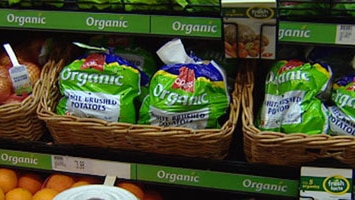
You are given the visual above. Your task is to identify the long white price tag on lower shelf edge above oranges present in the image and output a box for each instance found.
[52,155,131,179]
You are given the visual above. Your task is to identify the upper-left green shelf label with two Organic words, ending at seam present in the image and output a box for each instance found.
[0,10,150,33]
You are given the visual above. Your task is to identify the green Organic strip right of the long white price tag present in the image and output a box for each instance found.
[137,164,298,197]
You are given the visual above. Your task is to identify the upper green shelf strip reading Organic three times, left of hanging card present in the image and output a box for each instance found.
[0,9,222,39]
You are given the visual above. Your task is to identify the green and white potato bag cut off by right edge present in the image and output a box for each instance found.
[329,75,355,136]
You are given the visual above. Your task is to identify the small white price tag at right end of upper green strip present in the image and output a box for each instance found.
[335,24,355,44]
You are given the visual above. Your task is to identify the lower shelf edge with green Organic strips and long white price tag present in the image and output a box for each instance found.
[0,140,299,198]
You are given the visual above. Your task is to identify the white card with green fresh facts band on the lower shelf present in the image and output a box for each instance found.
[300,167,353,200]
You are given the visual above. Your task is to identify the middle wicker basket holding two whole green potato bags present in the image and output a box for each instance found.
[37,61,241,159]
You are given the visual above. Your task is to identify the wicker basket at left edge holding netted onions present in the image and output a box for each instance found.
[0,63,50,141]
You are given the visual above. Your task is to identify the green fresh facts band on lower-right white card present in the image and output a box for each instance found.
[300,175,352,195]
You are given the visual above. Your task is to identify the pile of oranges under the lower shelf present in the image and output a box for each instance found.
[0,168,163,200]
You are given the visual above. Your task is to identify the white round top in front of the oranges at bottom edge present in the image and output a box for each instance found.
[54,185,138,200]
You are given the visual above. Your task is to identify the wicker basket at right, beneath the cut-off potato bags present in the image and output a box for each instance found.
[241,61,355,168]
